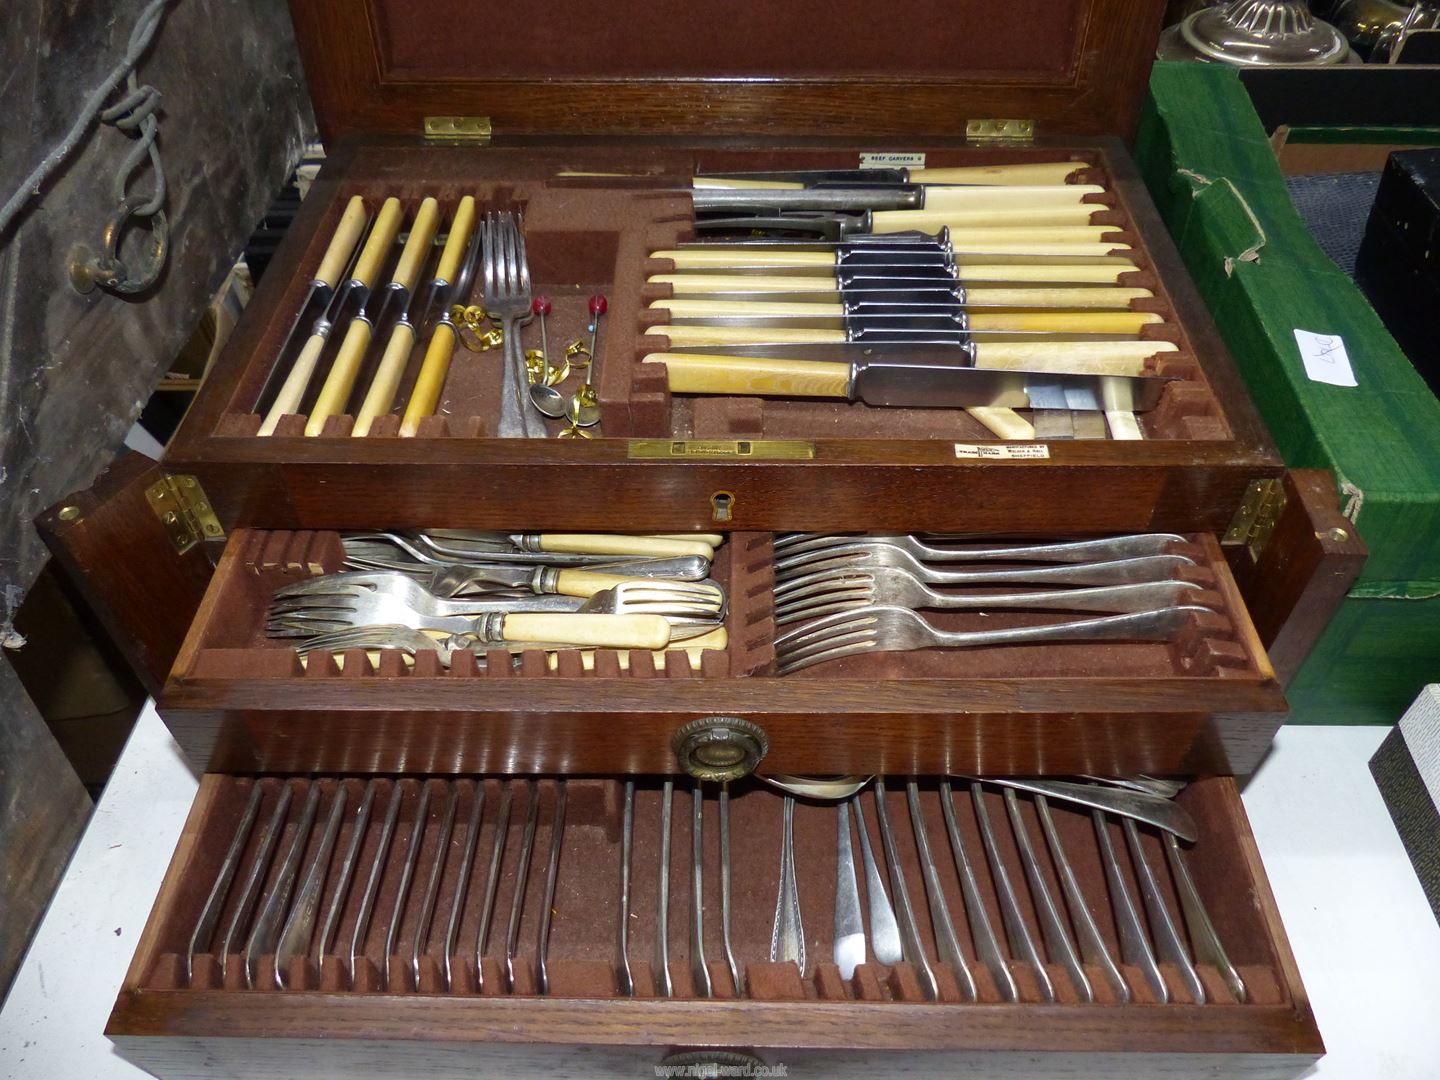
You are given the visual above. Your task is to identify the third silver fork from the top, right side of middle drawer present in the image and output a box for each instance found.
[775,566,1200,625]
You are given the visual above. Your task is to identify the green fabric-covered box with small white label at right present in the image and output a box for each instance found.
[1135,62,1440,723]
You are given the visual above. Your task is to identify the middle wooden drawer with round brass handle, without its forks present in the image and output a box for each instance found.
[160,530,1284,775]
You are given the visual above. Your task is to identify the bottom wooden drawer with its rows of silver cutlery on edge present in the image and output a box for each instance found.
[108,773,1322,1077]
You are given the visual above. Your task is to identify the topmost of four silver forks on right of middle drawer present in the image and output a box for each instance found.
[775,533,1185,569]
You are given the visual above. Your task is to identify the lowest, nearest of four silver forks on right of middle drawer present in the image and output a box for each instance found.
[775,608,1211,675]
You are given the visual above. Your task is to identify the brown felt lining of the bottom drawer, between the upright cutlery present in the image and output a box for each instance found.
[145,778,1284,1005]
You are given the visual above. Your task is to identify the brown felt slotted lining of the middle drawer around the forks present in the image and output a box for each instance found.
[181,530,1256,680]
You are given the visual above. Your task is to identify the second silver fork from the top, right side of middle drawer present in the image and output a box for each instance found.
[775,544,1195,599]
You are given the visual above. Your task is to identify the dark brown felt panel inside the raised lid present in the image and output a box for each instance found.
[370,0,1080,83]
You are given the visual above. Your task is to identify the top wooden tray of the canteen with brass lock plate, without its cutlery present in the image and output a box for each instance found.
[166,140,1279,531]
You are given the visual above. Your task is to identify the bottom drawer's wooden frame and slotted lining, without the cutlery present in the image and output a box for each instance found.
[108,773,1320,1077]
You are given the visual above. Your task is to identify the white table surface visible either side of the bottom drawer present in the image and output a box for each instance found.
[0,707,1440,1080]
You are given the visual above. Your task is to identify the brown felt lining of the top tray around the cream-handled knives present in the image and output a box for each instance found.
[216,147,1231,441]
